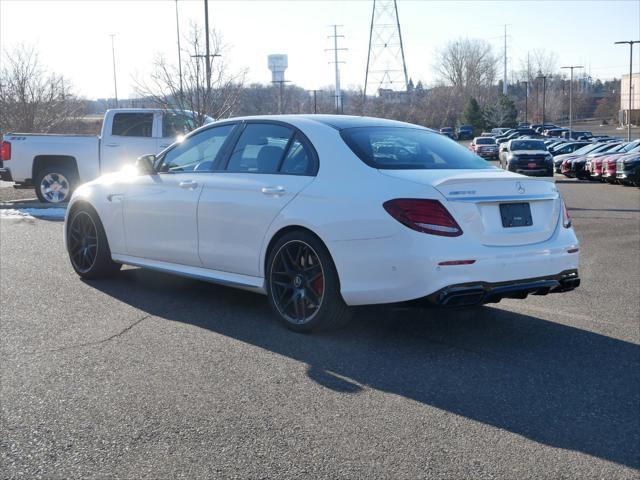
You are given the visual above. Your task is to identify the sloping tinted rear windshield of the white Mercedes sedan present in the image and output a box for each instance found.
[340,127,496,170]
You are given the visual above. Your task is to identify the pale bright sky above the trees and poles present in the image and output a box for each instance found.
[0,0,640,98]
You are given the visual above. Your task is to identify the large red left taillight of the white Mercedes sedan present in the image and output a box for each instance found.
[383,198,462,237]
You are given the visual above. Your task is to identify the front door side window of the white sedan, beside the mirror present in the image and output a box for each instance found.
[156,124,235,173]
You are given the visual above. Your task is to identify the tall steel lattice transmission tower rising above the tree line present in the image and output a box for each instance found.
[364,0,409,98]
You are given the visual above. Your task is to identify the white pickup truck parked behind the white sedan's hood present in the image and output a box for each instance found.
[0,108,213,203]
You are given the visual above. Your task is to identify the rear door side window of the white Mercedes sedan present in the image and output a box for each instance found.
[226,123,294,173]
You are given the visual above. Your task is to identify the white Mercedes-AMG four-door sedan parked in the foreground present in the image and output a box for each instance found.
[65,115,580,332]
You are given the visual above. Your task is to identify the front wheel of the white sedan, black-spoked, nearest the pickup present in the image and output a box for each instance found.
[66,205,122,279]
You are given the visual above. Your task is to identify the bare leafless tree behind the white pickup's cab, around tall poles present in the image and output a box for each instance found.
[136,24,244,126]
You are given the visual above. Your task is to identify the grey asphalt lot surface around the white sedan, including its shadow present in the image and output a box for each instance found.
[0,177,640,479]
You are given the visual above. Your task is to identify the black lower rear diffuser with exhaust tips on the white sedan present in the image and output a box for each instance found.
[416,270,580,307]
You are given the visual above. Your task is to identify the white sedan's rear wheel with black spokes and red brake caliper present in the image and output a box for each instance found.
[266,231,350,332]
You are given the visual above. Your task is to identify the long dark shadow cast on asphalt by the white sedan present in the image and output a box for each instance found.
[90,269,640,468]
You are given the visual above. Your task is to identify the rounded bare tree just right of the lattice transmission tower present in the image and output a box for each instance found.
[434,38,496,97]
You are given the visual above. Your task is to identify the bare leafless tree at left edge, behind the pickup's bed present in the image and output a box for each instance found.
[0,44,83,133]
